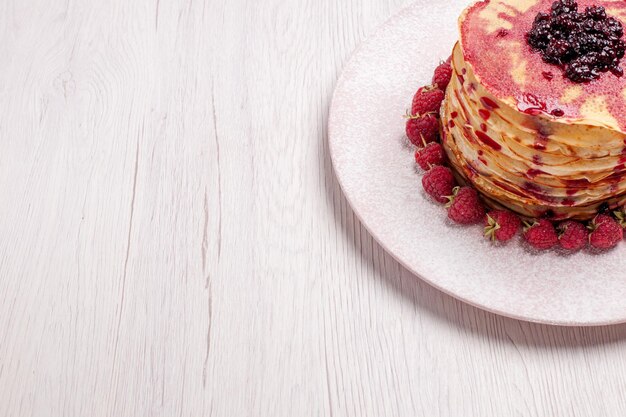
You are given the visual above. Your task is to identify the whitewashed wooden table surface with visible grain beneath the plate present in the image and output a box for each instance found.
[0,0,626,417]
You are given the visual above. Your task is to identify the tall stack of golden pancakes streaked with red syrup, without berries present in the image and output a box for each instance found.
[441,0,626,220]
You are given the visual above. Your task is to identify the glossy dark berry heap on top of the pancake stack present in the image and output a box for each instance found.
[526,0,626,83]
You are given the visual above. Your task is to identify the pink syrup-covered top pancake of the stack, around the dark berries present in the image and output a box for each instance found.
[459,0,626,132]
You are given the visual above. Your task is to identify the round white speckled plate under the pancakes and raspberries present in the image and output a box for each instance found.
[328,0,626,326]
